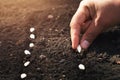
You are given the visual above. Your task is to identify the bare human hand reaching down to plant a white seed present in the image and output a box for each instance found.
[70,0,120,49]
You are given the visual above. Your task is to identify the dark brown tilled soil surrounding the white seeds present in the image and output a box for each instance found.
[0,0,120,80]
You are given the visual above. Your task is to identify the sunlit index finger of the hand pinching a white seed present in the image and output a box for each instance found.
[70,1,88,49]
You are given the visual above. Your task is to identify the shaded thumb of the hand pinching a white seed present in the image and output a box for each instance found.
[81,18,103,49]
